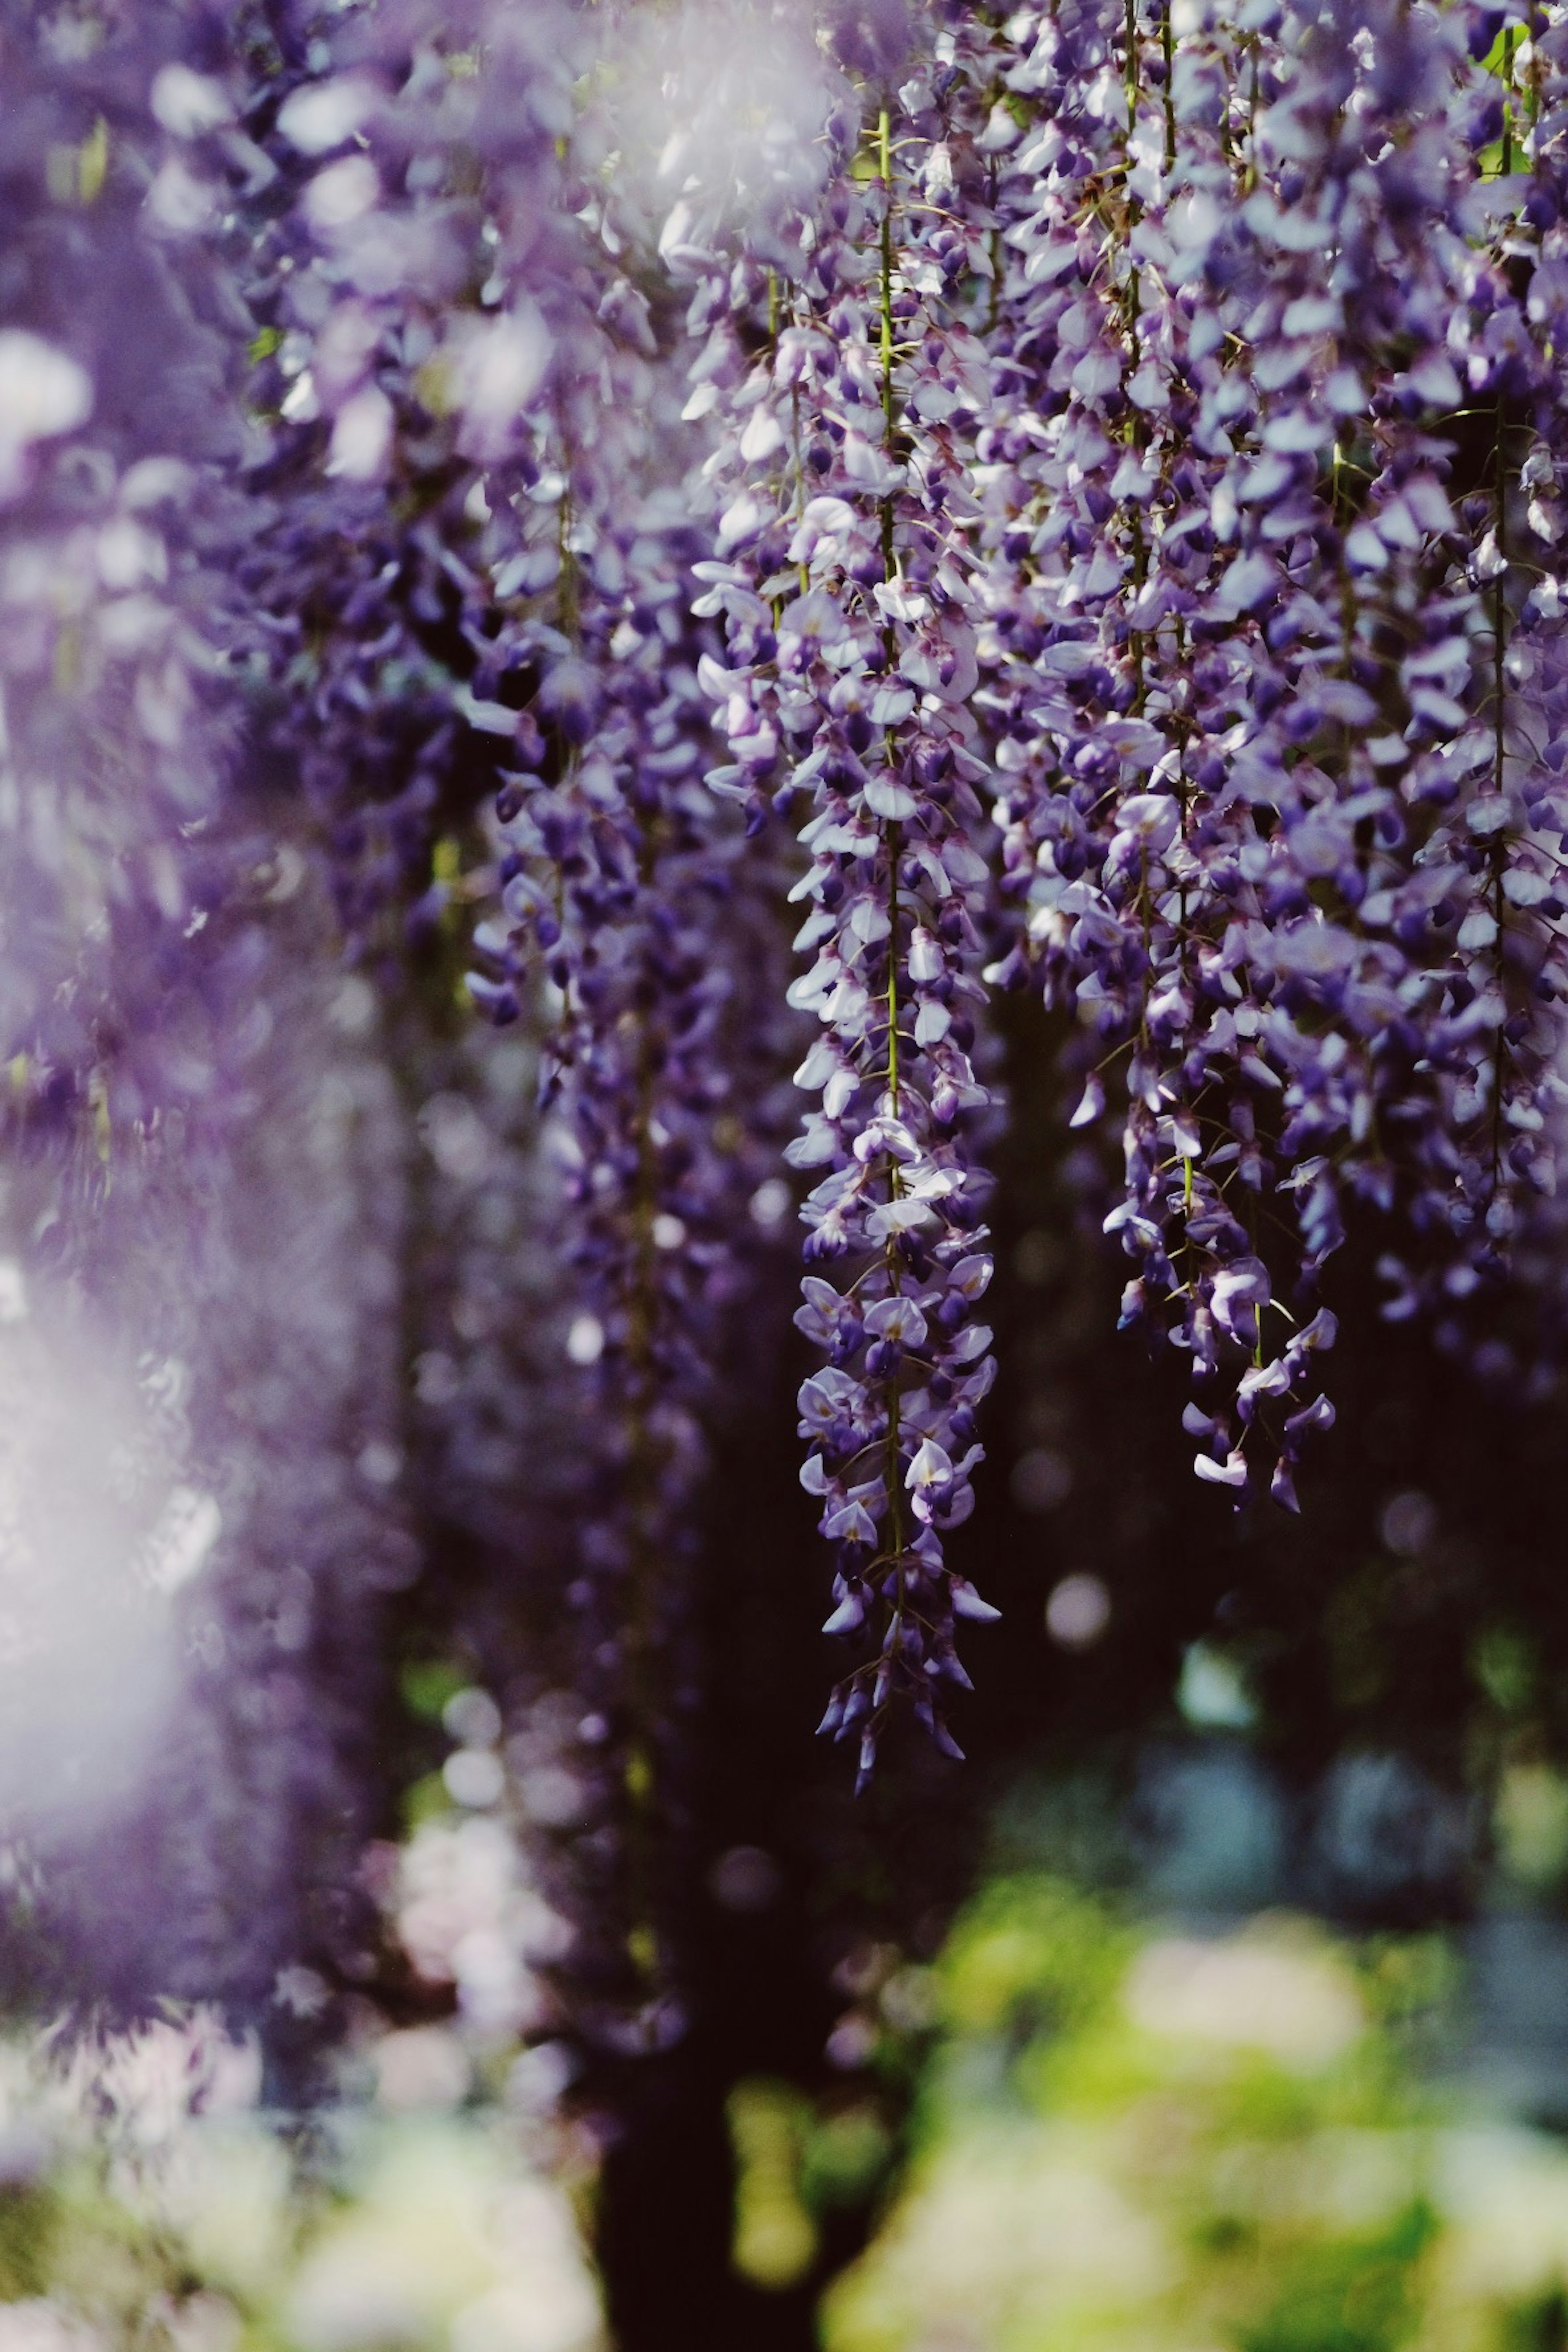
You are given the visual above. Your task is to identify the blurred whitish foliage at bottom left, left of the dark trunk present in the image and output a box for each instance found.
[0,2016,604,2352]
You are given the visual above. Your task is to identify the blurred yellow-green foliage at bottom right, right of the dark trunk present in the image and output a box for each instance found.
[823,1877,1568,2352]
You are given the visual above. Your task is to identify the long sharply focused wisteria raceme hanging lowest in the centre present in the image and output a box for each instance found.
[696,33,994,1776]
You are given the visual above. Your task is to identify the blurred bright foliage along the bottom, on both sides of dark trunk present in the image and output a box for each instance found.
[15,1853,1568,2352]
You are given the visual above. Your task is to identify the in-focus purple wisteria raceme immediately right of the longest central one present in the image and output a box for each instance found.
[982,9,1333,1498]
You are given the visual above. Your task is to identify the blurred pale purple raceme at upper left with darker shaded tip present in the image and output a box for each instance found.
[215,0,588,946]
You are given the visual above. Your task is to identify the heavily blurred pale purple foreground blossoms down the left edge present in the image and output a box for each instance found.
[0,5,435,2016]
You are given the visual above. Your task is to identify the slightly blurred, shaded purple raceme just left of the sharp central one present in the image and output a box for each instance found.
[470,444,769,1966]
